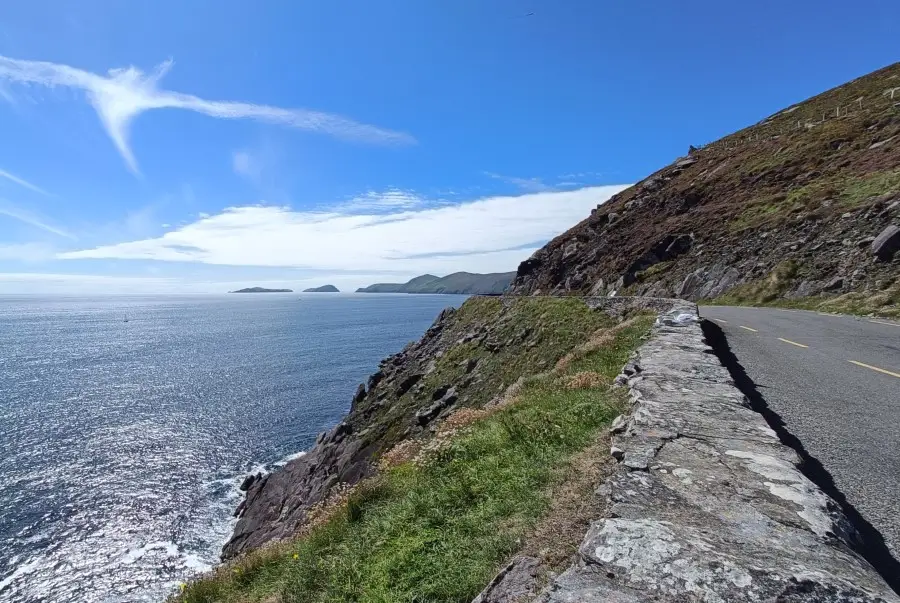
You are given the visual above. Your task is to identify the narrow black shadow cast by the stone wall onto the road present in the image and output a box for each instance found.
[701,320,900,594]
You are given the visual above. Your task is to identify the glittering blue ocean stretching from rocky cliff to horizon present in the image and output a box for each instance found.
[0,294,465,603]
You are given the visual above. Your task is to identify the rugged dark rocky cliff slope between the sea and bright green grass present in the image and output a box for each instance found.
[222,297,624,559]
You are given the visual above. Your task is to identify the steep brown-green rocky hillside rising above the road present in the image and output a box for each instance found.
[510,63,900,314]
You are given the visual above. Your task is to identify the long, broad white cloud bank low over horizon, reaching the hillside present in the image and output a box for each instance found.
[57,185,626,273]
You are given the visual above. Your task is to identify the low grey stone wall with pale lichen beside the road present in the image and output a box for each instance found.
[536,301,900,603]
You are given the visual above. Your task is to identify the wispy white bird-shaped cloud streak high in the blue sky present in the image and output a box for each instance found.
[0,56,415,174]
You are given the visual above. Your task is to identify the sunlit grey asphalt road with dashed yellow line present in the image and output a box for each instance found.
[700,306,900,560]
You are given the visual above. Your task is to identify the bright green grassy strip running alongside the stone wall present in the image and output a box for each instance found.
[176,316,652,603]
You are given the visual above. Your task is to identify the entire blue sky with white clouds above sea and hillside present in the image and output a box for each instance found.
[0,0,900,293]
